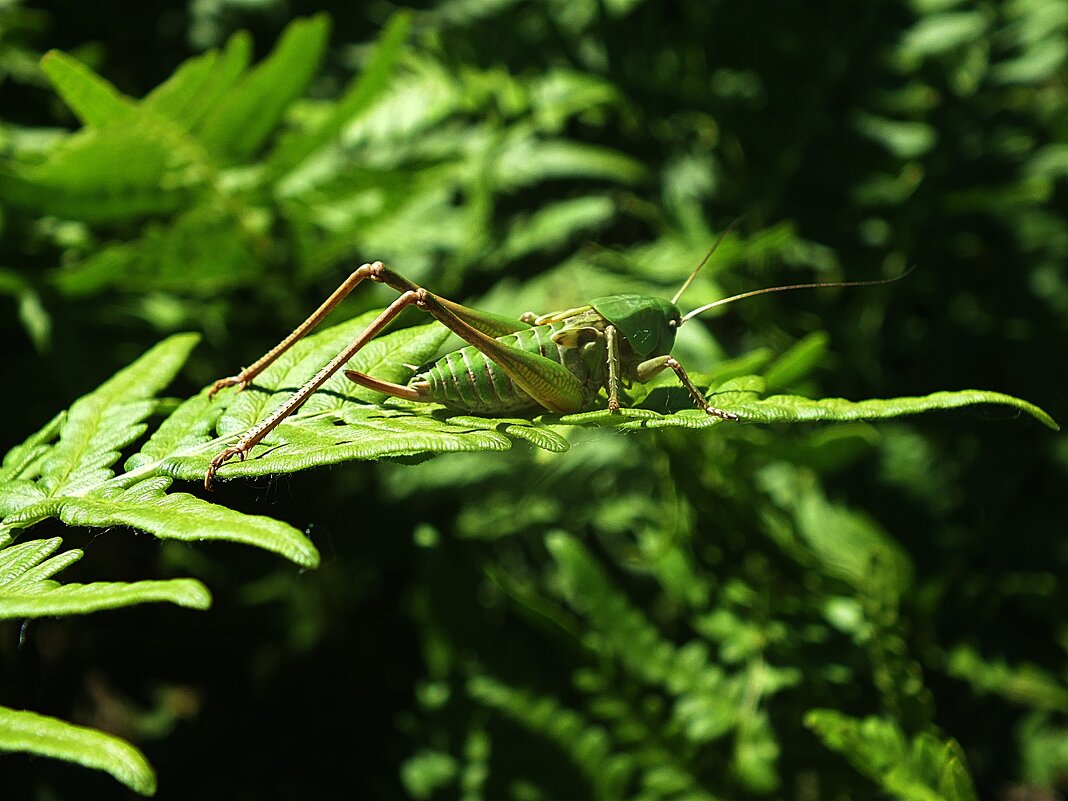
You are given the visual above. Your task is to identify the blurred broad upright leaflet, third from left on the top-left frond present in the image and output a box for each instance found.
[199,14,330,161]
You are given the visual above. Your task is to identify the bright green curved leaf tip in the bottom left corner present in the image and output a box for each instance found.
[0,706,156,796]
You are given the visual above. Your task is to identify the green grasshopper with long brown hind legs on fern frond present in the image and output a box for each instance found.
[204,238,897,489]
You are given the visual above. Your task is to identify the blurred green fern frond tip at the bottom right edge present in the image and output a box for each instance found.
[805,709,977,801]
